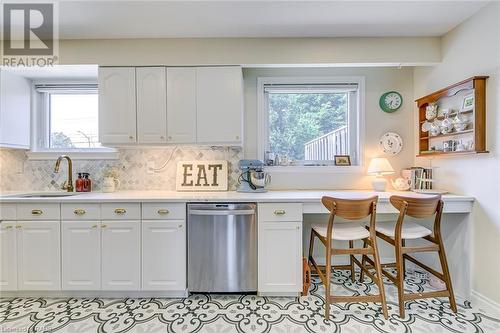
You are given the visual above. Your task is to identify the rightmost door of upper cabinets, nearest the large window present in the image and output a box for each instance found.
[196,67,243,144]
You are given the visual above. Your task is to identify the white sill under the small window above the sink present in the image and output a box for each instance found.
[26,149,119,161]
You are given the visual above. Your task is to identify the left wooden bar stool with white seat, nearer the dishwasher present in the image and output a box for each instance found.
[309,196,387,320]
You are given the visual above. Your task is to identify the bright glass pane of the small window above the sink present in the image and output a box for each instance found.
[50,94,101,148]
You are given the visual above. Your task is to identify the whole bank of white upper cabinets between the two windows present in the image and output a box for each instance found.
[99,66,243,145]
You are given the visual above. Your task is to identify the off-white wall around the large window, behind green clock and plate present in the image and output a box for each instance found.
[243,67,414,189]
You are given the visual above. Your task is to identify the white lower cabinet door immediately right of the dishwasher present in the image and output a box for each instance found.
[258,222,302,295]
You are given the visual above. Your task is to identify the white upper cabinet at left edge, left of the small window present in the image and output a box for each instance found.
[0,70,31,149]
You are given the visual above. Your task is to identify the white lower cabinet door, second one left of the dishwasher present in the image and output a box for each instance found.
[101,220,141,290]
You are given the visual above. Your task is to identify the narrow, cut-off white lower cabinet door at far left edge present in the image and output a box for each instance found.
[0,221,17,291]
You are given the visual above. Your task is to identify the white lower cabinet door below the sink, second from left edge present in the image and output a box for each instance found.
[16,221,61,290]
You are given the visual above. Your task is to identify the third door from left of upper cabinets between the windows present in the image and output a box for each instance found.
[167,67,196,143]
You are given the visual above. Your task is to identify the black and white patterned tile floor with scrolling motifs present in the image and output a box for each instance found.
[0,271,500,333]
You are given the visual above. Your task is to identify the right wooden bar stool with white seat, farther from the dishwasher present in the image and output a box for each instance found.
[368,195,457,318]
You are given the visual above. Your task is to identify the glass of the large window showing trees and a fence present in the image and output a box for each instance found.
[268,92,349,161]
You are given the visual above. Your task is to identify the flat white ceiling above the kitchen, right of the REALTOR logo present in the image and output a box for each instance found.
[59,1,488,39]
